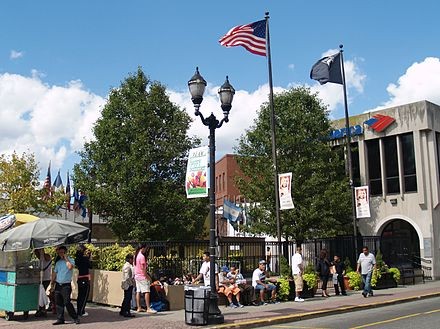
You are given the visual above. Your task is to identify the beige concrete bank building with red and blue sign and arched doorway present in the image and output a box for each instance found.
[332,101,440,279]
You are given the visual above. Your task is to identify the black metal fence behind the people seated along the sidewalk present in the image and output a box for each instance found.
[90,236,380,278]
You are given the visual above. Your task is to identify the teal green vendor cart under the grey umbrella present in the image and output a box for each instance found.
[0,250,40,320]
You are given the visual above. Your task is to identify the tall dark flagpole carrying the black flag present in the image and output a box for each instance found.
[339,45,358,261]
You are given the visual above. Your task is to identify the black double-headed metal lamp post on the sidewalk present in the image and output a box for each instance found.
[188,67,235,324]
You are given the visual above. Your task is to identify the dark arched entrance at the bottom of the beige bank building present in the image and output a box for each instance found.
[380,219,420,267]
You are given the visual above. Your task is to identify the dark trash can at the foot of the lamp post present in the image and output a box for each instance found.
[185,285,211,325]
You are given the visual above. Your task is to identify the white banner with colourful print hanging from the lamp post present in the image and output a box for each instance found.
[185,146,209,198]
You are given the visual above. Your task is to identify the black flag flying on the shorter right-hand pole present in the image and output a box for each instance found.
[310,53,343,85]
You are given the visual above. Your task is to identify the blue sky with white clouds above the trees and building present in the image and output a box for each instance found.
[0,0,440,181]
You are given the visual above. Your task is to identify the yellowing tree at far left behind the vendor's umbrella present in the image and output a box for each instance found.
[0,152,65,215]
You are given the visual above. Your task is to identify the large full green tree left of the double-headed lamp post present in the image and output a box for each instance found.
[74,69,208,240]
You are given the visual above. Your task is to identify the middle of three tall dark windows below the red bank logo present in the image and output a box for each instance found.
[383,136,400,194]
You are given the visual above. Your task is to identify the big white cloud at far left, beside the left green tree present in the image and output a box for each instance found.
[0,71,105,171]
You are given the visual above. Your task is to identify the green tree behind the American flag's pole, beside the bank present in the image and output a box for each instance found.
[237,87,351,243]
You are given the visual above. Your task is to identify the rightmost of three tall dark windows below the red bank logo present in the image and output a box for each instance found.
[400,133,416,192]
